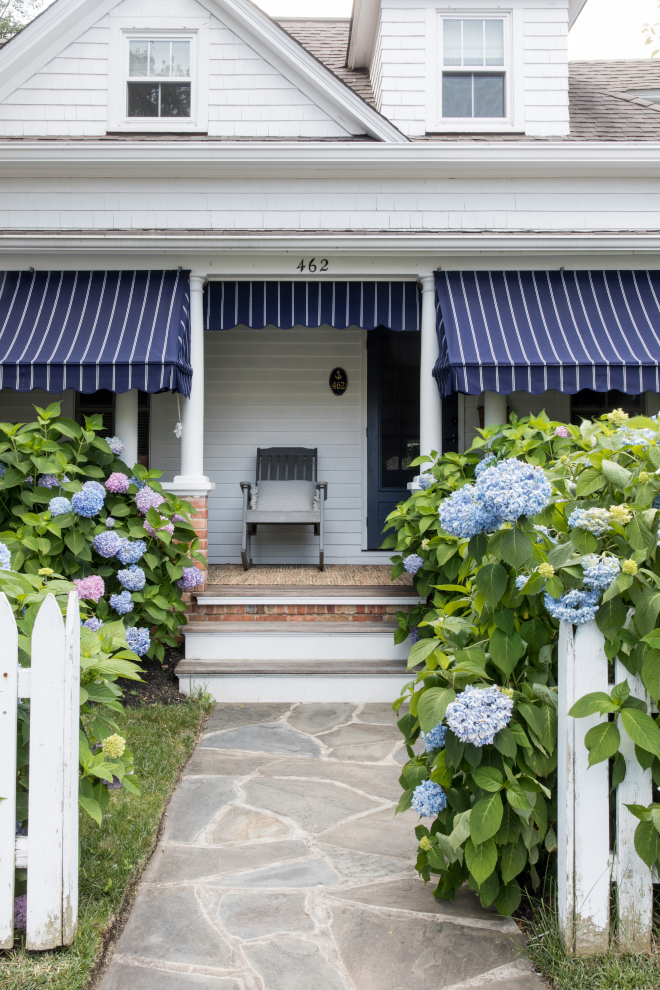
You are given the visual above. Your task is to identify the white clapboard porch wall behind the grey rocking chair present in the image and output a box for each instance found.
[152,327,372,564]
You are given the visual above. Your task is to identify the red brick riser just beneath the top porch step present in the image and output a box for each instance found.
[186,603,413,622]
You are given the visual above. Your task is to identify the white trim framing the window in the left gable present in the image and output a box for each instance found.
[108,17,209,134]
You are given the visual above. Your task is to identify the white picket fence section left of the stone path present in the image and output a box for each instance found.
[0,591,80,949]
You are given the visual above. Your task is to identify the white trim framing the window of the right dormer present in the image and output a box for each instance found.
[426,3,525,134]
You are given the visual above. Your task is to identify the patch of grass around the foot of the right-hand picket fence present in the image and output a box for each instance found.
[525,897,660,990]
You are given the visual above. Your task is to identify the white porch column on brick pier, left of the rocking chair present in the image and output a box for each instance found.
[173,273,213,495]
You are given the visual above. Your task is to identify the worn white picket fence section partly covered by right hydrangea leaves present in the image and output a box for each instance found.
[557,622,653,956]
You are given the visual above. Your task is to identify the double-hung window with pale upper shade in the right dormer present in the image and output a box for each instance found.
[442,17,507,120]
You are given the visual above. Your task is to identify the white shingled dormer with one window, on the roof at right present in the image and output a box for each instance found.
[347,0,586,138]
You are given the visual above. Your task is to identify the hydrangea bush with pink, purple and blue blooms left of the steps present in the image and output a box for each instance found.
[0,402,204,660]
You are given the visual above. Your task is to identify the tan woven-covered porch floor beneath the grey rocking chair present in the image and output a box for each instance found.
[208,564,412,588]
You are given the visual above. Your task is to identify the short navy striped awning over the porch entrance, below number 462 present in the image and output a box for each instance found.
[204,282,420,330]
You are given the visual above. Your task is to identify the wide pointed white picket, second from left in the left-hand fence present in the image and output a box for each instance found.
[26,595,66,950]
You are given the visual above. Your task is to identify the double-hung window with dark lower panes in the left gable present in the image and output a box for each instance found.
[126,37,191,119]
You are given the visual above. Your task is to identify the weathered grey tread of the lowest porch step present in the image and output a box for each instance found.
[174,660,406,677]
